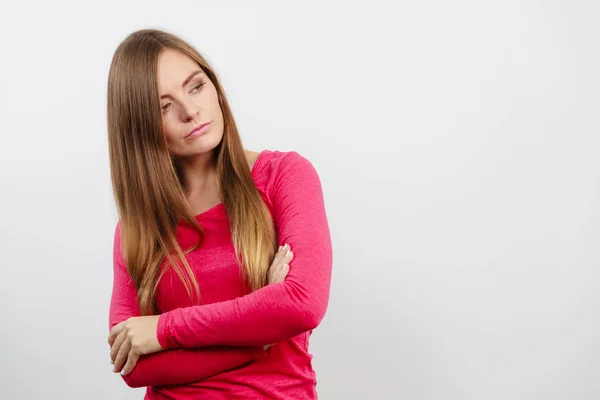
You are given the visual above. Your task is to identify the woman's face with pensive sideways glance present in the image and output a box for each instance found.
[158,49,223,158]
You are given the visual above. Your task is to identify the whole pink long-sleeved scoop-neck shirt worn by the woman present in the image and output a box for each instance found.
[109,150,332,400]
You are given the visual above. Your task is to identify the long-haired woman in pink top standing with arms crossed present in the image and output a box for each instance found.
[108,29,332,399]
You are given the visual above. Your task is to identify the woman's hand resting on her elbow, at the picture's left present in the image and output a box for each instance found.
[108,315,164,375]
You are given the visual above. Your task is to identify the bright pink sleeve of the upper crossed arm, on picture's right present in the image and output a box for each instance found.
[157,152,332,348]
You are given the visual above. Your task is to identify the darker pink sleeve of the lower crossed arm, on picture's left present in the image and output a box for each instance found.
[109,224,265,387]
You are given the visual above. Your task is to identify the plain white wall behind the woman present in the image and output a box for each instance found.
[0,0,600,400]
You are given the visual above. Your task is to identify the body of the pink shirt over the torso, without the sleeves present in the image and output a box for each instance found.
[146,150,317,399]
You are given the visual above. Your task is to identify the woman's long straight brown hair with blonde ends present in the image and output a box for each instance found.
[107,29,277,315]
